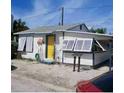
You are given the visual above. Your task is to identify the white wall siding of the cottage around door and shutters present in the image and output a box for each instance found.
[18,32,111,66]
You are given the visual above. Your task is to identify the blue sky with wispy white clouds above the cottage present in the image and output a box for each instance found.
[11,0,113,33]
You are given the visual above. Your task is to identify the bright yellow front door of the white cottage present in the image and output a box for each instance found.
[47,35,54,59]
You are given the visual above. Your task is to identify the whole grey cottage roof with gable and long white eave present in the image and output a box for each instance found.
[14,23,113,37]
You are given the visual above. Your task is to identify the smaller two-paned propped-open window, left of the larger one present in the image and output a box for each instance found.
[63,40,75,51]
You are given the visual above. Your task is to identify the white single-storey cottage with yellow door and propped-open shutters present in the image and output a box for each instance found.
[15,24,113,66]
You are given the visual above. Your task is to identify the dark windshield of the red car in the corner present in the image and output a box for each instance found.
[91,72,113,92]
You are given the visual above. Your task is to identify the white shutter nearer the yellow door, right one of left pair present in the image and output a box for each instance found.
[26,36,33,52]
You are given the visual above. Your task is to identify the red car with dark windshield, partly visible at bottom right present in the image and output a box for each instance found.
[76,71,113,92]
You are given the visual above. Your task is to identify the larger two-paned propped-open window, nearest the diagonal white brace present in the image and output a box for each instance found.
[74,39,93,52]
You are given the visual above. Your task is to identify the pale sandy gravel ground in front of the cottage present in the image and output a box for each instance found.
[12,60,109,92]
